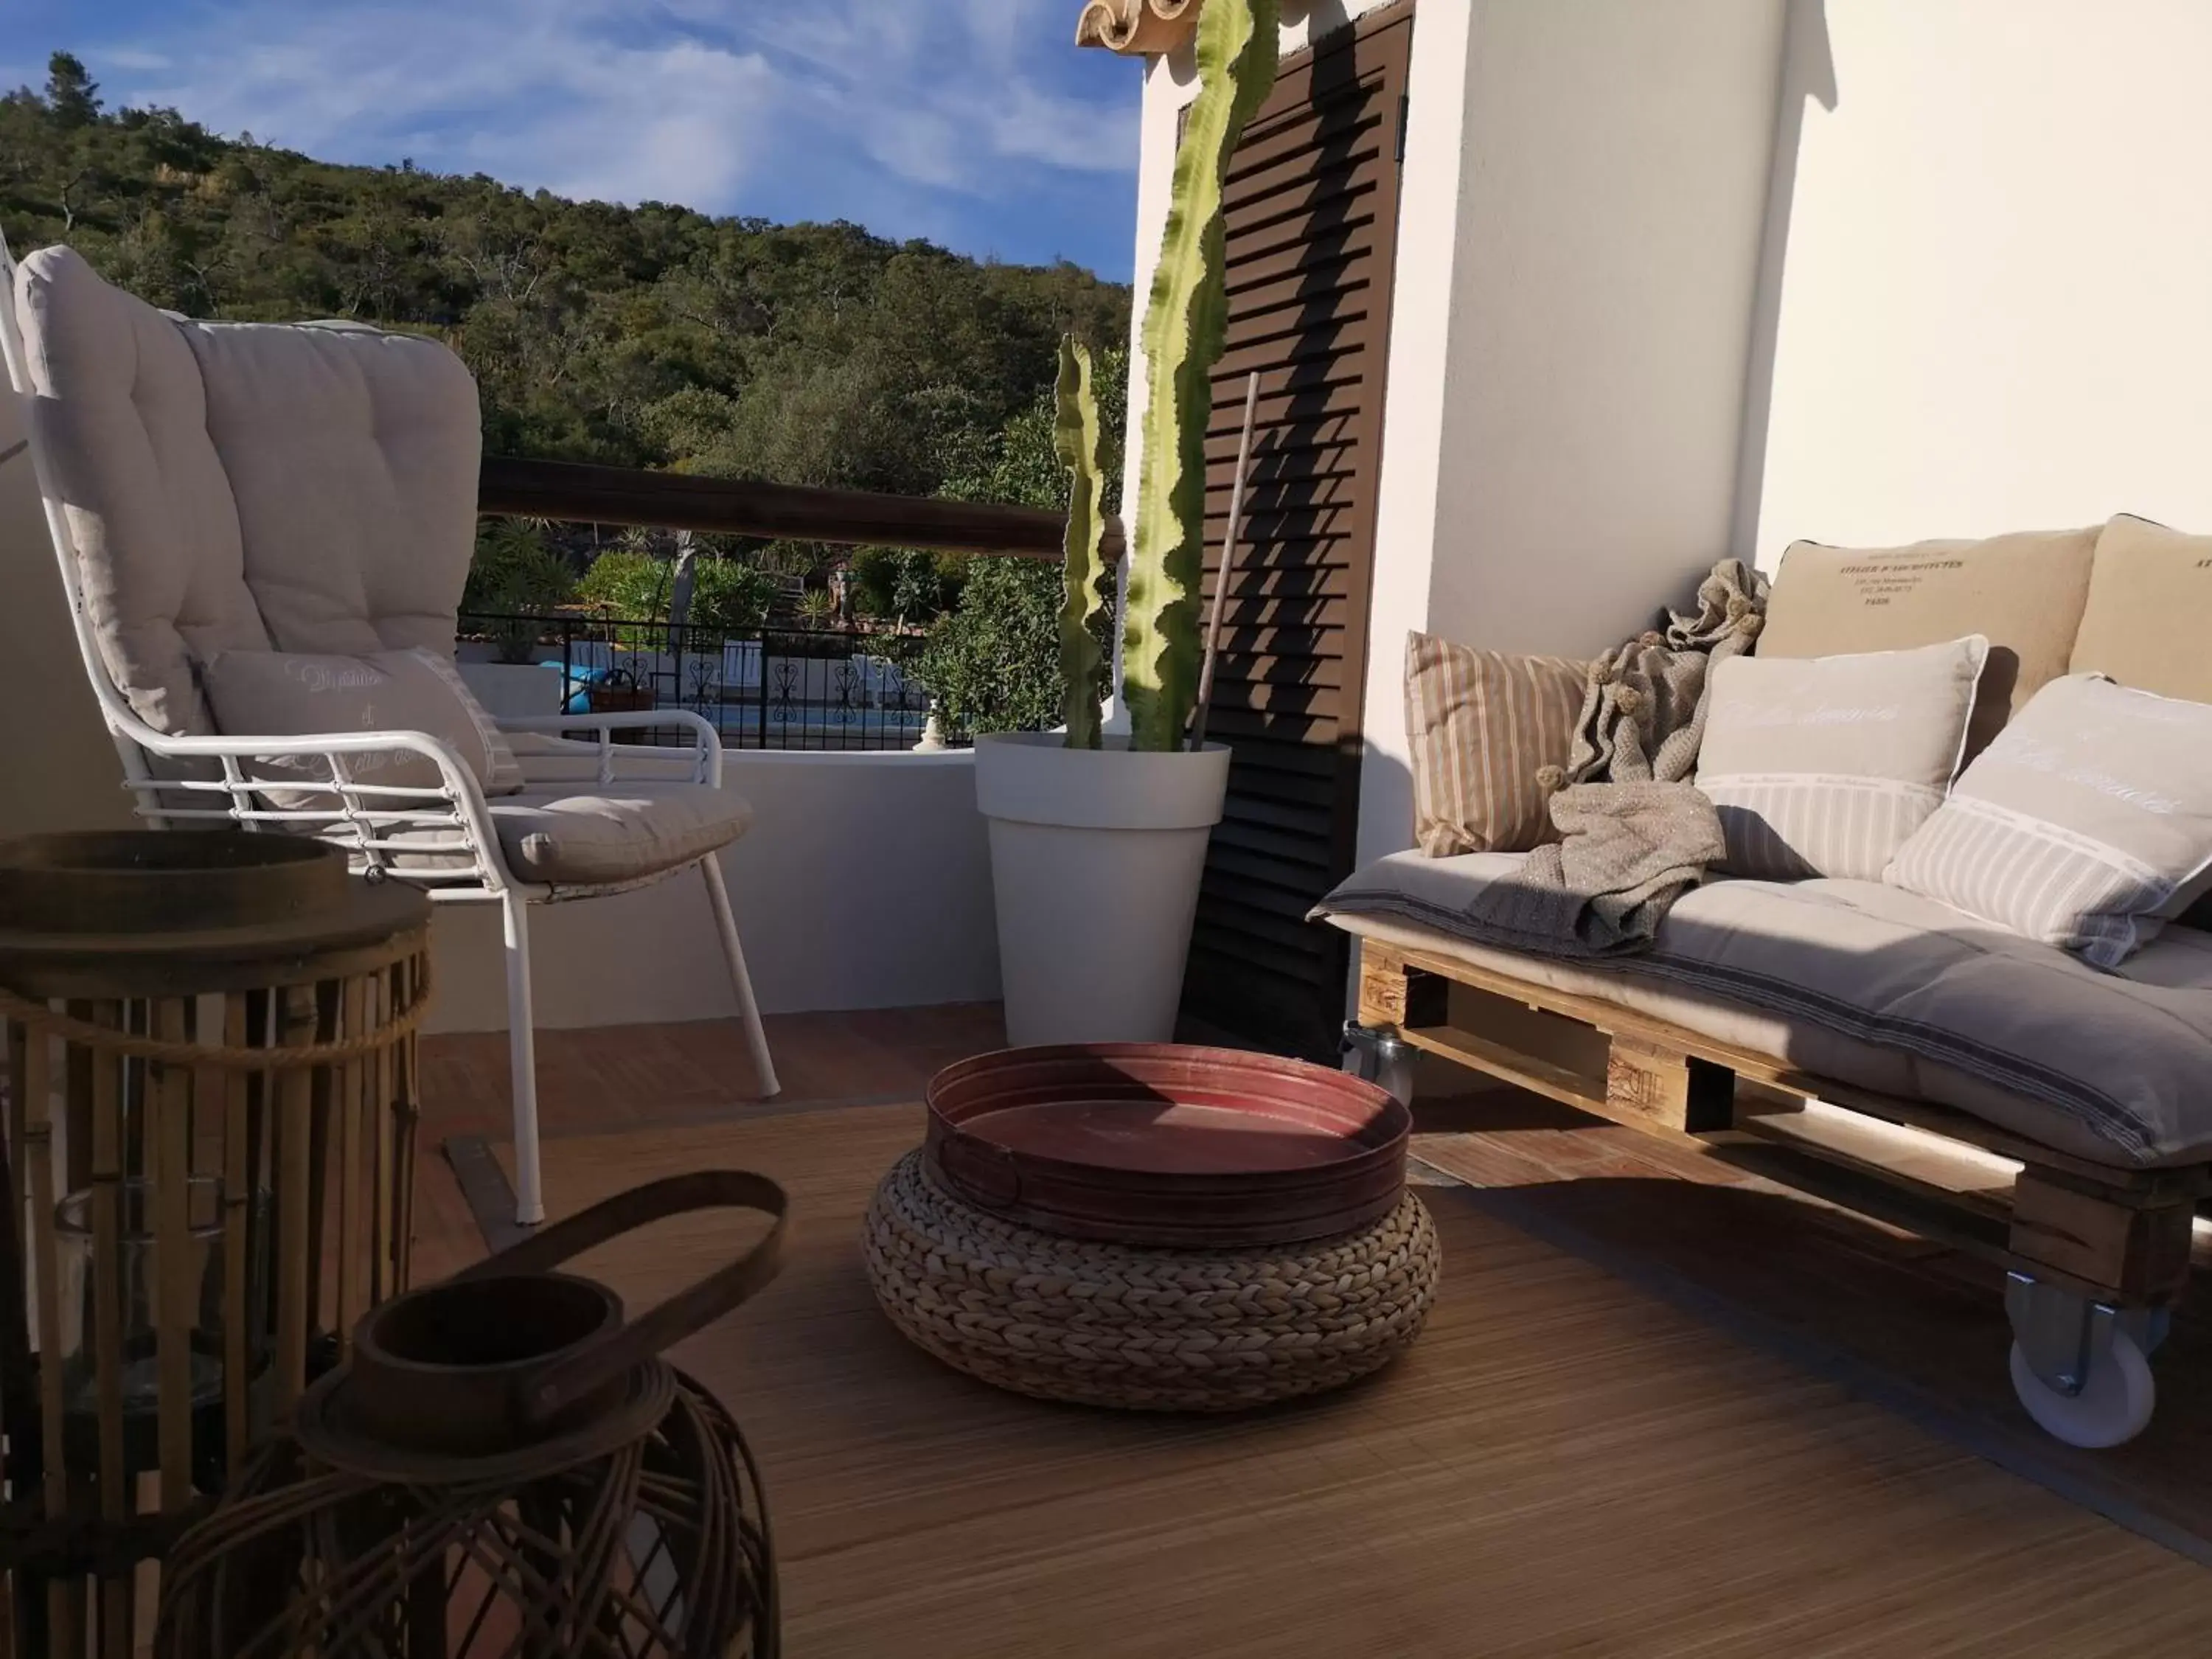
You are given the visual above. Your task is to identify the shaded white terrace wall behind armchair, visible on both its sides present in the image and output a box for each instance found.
[0,407,998,1031]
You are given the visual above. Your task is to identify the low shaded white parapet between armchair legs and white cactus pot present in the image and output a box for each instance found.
[431,750,998,1031]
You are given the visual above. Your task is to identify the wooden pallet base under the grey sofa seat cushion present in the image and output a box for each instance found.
[1360,940,2212,1307]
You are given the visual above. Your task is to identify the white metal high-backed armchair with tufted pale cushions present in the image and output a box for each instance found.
[0,239,779,1223]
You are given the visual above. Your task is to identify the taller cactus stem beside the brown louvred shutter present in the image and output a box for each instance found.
[1124,0,1279,750]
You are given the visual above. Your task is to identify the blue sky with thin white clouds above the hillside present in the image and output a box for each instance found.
[17,0,1139,281]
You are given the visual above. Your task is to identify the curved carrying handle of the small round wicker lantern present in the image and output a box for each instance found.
[453,1170,790,1425]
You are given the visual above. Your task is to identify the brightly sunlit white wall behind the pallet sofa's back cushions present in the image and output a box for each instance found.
[1739,0,2212,564]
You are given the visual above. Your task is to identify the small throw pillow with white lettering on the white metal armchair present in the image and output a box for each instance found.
[206,650,522,805]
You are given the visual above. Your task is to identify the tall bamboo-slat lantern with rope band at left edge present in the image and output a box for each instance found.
[0,832,429,1659]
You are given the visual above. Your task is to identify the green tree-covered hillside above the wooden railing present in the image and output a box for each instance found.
[0,53,1128,495]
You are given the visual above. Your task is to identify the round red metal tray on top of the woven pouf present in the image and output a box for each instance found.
[927,1042,1413,1248]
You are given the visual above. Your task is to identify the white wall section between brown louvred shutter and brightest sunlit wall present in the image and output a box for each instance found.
[1360,0,1785,858]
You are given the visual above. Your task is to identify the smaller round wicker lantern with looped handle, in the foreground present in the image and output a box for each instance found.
[155,1170,785,1659]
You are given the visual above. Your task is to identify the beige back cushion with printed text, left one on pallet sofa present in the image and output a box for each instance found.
[1759,529,2097,759]
